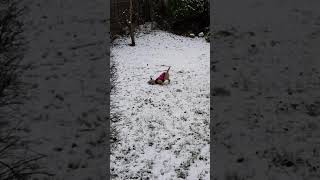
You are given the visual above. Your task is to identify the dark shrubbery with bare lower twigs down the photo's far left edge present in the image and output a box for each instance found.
[0,0,49,180]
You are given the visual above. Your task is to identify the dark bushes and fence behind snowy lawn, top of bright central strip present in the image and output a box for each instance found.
[111,0,210,41]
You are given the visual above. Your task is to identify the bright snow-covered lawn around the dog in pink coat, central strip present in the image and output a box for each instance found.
[110,31,210,179]
